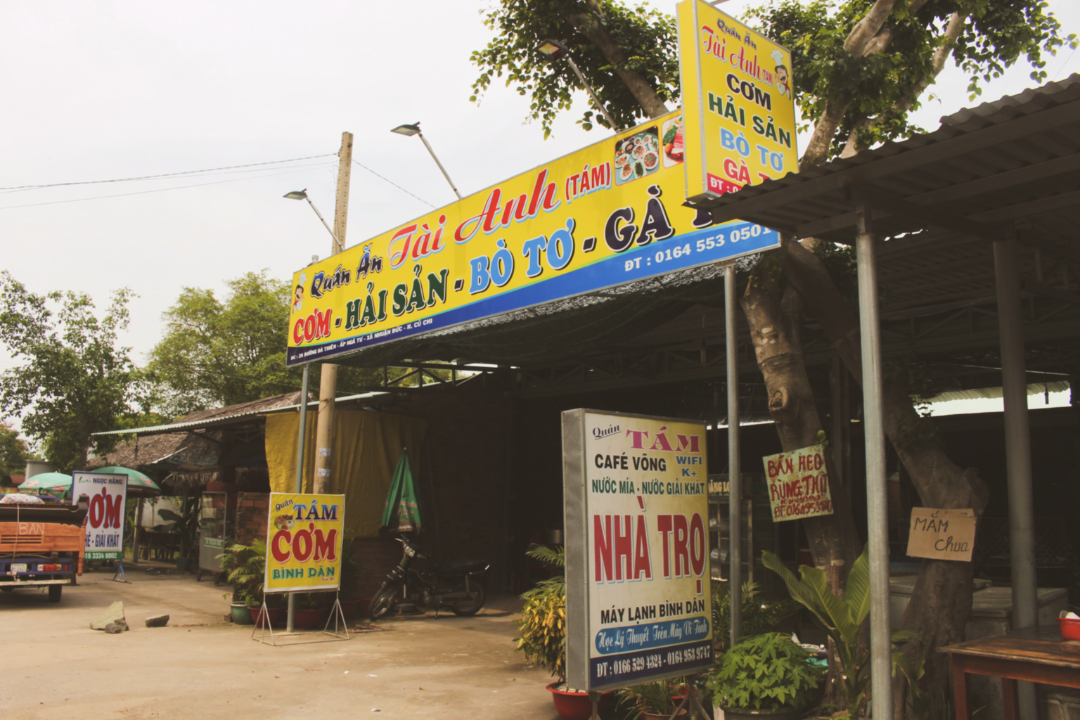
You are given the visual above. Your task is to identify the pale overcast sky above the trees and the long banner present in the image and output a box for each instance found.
[0,0,1080,382]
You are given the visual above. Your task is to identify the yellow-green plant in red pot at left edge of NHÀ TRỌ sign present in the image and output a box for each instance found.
[514,545,611,720]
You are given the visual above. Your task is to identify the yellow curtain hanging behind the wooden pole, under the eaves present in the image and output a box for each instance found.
[266,410,428,538]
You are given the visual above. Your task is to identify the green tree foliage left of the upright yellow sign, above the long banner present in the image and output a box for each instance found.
[472,0,679,138]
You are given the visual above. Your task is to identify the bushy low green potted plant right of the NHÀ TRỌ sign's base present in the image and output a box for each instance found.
[705,633,823,720]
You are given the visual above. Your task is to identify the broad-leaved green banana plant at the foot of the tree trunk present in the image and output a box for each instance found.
[761,547,918,718]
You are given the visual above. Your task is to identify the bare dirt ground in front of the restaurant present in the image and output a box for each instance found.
[0,569,558,720]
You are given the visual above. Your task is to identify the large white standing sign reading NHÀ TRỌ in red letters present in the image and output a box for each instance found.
[563,409,713,691]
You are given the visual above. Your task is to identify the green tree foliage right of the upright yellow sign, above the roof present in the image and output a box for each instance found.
[748,0,1076,161]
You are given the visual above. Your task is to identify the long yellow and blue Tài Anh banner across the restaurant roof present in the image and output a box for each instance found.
[287,113,780,365]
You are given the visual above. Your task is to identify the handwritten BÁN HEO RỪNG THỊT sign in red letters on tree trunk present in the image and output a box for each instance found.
[762,445,833,522]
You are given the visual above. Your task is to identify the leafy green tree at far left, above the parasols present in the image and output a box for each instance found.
[0,272,134,471]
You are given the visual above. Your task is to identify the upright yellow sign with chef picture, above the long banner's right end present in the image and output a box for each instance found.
[676,0,798,202]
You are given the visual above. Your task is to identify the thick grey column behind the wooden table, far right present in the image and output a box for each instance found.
[994,239,1039,718]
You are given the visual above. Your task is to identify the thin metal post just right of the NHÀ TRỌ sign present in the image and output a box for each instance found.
[724,264,753,646]
